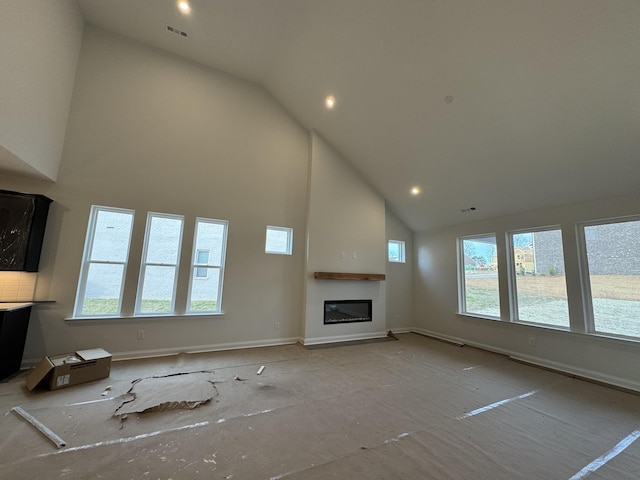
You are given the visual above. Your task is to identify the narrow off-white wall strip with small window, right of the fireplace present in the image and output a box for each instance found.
[386,208,415,332]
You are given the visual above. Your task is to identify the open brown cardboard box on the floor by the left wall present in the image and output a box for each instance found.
[26,348,111,390]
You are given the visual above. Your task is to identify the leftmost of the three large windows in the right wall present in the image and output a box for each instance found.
[458,235,500,318]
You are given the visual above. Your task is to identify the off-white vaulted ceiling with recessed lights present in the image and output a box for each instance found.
[66,0,640,231]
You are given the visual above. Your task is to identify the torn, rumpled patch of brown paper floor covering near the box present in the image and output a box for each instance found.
[113,371,218,416]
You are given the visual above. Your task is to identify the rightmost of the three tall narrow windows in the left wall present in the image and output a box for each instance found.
[187,218,227,313]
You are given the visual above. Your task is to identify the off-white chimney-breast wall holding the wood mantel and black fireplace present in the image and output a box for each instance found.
[304,133,386,344]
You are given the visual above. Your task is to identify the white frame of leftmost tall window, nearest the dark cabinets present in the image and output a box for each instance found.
[73,205,135,319]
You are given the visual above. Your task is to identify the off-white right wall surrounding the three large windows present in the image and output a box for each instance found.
[414,190,640,390]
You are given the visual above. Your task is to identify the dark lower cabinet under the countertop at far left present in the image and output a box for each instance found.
[0,306,31,380]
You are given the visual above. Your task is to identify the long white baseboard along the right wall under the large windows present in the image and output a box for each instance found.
[413,328,640,392]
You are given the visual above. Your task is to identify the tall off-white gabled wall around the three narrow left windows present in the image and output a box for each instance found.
[0,26,309,364]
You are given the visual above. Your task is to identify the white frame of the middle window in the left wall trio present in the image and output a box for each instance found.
[134,212,185,317]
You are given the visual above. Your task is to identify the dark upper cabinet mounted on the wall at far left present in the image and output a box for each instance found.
[0,190,51,272]
